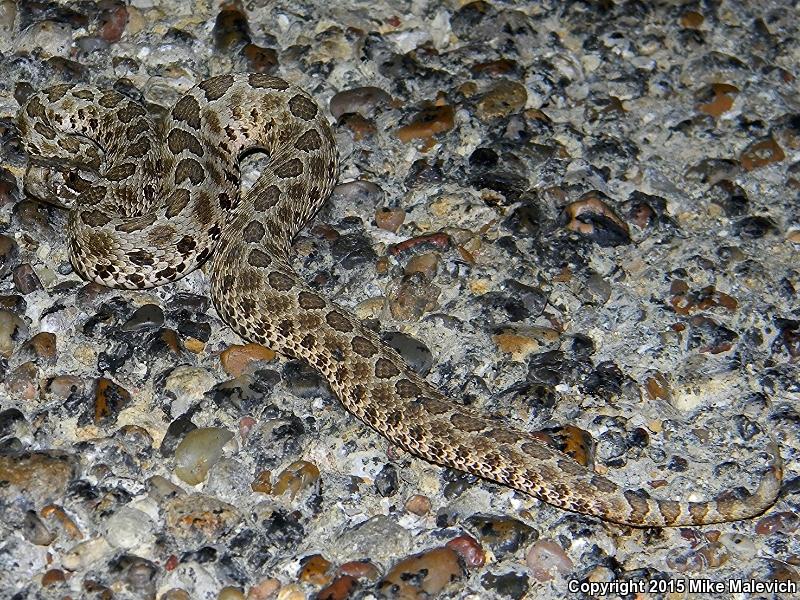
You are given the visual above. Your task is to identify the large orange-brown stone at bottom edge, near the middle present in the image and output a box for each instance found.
[378,548,464,598]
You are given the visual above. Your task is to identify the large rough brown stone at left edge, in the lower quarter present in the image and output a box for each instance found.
[0,450,76,506]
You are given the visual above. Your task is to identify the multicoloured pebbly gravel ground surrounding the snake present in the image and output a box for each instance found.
[0,0,800,600]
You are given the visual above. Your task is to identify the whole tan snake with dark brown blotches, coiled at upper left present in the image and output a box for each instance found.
[18,74,782,527]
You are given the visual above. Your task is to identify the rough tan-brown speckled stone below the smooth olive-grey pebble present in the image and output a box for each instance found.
[164,494,242,545]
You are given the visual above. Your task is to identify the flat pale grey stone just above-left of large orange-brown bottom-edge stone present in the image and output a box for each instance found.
[330,515,413,564]
